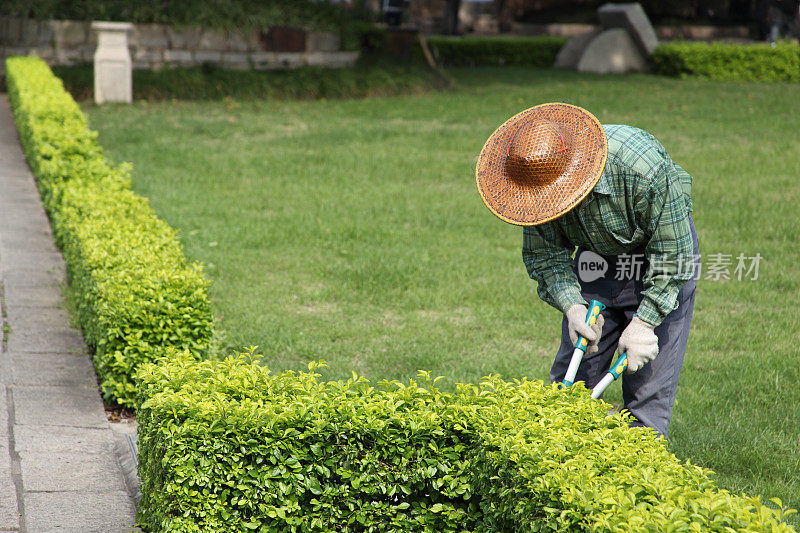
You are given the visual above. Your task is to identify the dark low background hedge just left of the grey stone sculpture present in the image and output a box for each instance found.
[428,37,567,67]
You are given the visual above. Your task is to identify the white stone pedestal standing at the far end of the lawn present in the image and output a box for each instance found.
[92,22,133,104]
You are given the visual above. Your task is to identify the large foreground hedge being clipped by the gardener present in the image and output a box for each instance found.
[137,353,793,533]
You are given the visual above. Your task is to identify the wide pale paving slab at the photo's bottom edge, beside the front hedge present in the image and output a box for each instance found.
[24,491,138,533]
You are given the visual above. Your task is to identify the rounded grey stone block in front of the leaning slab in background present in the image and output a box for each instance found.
[577,28,647,74]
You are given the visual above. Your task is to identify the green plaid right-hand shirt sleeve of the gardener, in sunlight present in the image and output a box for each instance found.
[634,160,694,326]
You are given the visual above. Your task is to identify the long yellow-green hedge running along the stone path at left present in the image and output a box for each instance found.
[6,57,212,406]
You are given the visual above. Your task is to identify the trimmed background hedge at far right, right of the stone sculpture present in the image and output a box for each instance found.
[652,41,800,81]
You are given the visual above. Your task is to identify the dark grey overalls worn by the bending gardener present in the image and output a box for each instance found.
[550,219,699,437]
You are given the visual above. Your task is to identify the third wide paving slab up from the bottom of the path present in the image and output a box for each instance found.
[14,424,114,453]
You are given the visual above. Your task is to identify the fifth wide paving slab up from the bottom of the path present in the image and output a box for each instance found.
[11,353,97,387]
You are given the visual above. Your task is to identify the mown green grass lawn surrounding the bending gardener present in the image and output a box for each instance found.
[85,68,800,523]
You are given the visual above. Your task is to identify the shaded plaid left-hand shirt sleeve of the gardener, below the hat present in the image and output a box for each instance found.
[522,222,587,313]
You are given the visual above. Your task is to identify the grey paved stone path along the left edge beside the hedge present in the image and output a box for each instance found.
[0,94,136,533]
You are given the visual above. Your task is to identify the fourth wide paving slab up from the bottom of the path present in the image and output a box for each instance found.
[12,385,108,428]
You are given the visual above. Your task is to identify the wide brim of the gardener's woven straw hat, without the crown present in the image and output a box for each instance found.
[475,103,608,226]
